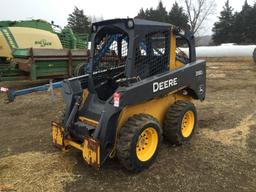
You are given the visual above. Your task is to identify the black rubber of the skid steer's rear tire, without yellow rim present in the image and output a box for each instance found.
[163,100,197,145]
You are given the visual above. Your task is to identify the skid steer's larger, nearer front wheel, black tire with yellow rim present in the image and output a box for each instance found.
[117,114,162,172]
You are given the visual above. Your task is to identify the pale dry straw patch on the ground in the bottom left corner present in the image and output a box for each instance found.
[0,152,75,192]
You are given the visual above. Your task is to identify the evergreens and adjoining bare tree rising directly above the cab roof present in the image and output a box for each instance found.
[136,0,216,35]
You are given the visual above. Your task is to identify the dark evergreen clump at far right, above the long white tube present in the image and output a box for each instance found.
[212,0,256,44]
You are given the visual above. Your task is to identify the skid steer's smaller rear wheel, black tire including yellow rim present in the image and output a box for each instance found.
[164,100,197,145]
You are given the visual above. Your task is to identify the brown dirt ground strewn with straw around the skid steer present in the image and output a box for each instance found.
[0,62,256,192]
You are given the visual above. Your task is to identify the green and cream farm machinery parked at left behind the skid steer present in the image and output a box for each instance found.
[0,20,89,81]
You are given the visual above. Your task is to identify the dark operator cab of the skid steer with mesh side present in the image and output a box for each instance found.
[87,19,195,101]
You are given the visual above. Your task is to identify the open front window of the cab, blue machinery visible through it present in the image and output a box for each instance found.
[93,30,129,72]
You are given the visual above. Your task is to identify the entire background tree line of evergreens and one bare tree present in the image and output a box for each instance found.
[67,0,256,44]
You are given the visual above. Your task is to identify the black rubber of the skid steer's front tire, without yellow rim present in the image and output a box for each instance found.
[117,114,162,172]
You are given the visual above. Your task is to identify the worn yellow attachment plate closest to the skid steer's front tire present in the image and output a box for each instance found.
[83,137,100,169]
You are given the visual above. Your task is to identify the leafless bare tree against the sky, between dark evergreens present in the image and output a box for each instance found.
[183,0,216,33]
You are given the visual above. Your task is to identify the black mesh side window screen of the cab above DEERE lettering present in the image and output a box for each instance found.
[135,31,170,79]
